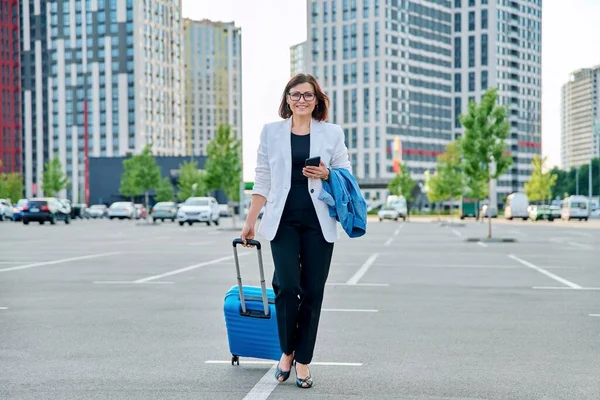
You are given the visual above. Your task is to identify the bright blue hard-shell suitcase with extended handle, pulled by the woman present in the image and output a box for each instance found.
[223,238,281,365]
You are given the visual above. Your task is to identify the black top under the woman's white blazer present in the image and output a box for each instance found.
[285,133,313,211]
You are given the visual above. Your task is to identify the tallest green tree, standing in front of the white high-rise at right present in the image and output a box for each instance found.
[460,88,512,238]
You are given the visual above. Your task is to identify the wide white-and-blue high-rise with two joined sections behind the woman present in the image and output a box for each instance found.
[307,0,541,198]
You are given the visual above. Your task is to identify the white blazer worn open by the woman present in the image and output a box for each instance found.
[252,118,352,243]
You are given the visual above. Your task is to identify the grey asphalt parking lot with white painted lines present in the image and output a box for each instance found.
[0,219,600,400]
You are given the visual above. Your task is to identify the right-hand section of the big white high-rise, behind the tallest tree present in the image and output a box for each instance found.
[452,0,542,195]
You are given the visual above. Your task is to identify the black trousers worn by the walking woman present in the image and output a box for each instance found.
[271,205,333,364]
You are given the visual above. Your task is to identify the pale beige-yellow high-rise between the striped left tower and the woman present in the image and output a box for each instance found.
[184,19,242,156]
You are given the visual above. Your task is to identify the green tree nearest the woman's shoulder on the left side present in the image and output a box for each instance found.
[204,125,243,226]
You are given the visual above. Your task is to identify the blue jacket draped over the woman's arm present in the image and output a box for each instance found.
[319,168,367,238]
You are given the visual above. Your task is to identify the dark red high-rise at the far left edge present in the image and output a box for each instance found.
[0,0,22,175]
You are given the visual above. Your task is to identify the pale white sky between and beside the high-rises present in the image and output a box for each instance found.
[182,0,600,181]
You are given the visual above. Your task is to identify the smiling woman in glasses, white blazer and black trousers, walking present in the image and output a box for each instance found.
[241,74,351,388]
